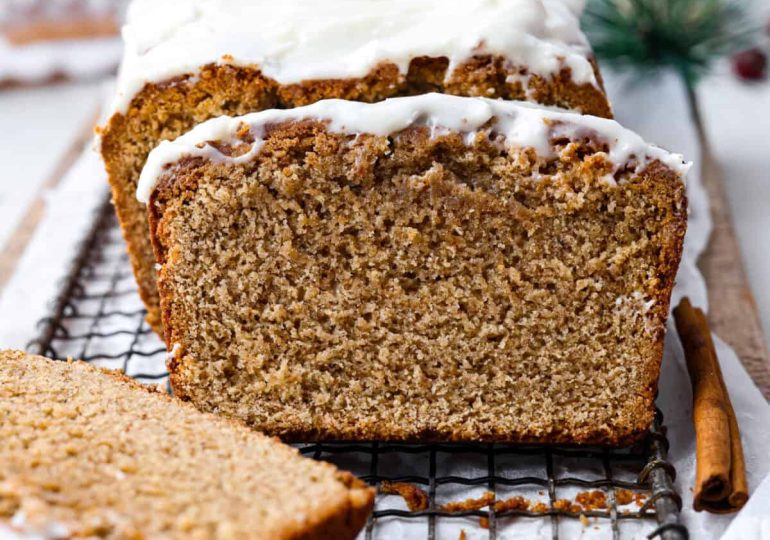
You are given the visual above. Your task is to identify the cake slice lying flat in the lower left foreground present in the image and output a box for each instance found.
[0,351,373,540]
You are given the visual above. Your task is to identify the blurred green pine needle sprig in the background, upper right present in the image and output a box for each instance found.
[583,0,758,85]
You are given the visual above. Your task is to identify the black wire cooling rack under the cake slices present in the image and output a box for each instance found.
[29,192,688,540]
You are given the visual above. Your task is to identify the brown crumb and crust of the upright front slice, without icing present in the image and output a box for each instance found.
[148,121,686,446]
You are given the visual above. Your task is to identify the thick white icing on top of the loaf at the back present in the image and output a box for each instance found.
[113,0,597,112]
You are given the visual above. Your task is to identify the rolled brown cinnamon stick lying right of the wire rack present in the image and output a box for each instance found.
[674,298,748,513]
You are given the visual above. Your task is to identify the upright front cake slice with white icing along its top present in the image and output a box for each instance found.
[139,94,686,444]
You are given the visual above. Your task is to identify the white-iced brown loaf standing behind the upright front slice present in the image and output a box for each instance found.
[101,0,612,331]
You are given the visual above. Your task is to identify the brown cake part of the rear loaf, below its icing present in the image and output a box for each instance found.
[102,56,612,334]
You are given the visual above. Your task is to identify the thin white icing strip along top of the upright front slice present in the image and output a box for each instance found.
[137,94,690,203]
